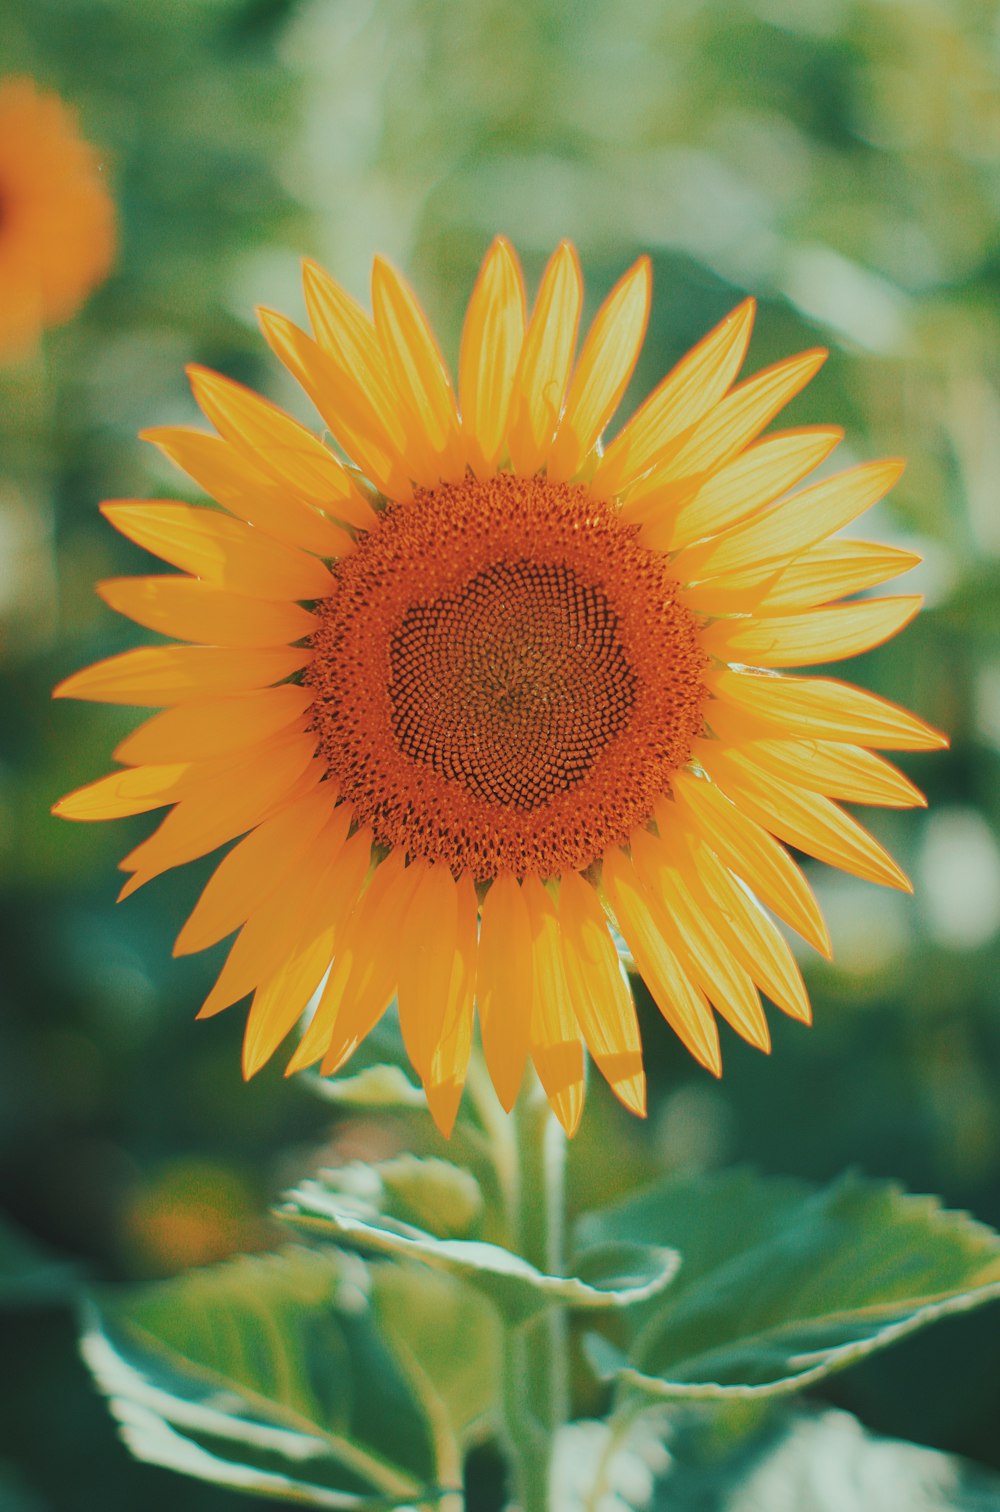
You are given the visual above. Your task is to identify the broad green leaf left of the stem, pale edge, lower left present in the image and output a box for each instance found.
[83,1249,496,1507]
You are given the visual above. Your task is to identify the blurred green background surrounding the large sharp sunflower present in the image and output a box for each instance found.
[0,0,1000,1512]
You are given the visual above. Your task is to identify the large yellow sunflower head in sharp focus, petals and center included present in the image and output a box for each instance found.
[56,239,946,1132]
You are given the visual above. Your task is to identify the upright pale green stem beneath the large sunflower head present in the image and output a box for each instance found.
[502,1080,569,1512]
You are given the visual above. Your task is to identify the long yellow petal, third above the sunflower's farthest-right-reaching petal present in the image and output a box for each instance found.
[678,460,905,581]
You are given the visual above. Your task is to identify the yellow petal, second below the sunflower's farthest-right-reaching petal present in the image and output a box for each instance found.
[697,741,914,892]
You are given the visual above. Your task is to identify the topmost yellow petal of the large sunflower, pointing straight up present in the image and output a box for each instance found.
[458,236,526,475]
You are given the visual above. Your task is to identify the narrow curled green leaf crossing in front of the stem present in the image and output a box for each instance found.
[278,1161,676,1323]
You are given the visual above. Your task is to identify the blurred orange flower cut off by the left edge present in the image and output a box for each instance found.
[0,79,115,358]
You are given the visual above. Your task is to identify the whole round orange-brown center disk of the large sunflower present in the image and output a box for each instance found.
[306,473,707,880]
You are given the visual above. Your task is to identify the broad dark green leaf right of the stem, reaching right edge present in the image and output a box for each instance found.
[579,1170,1000,1399]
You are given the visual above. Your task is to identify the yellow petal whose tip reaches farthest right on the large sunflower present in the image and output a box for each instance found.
[711,668,949,751]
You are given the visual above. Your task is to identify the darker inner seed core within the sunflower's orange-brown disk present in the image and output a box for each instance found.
[389,561,635,812]
